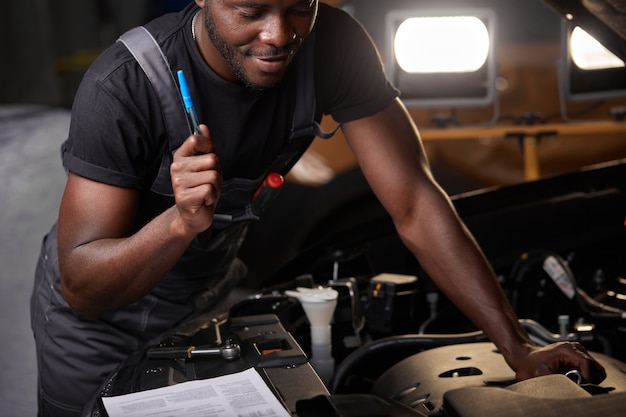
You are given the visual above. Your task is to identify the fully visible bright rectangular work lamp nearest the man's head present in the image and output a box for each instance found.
[384,9,496,108]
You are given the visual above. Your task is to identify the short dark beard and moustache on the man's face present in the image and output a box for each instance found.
[204,6,298,90]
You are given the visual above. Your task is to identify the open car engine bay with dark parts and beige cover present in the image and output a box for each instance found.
[92,161,626,416]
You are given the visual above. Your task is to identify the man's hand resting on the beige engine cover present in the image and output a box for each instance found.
[516,342,606,384]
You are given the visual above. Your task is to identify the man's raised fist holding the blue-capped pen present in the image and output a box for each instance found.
[170,125,222,234]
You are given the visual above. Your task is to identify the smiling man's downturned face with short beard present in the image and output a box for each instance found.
[203,0,318,89]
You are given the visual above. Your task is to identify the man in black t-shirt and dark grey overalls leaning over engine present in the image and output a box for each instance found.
[32,0,604,416]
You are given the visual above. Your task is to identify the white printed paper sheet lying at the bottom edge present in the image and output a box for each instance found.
[102,368,291,417]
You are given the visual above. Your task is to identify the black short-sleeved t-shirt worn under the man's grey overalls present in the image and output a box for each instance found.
[63,3,397,190]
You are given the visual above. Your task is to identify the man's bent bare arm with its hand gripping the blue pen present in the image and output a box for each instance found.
[58,127,221,318]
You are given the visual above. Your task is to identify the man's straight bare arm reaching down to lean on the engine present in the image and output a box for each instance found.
[343,96,604,381]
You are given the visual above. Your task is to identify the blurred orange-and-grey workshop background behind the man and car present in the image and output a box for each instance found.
[0,0,626,417]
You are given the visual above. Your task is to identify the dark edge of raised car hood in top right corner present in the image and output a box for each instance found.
[544,0,626,60]
